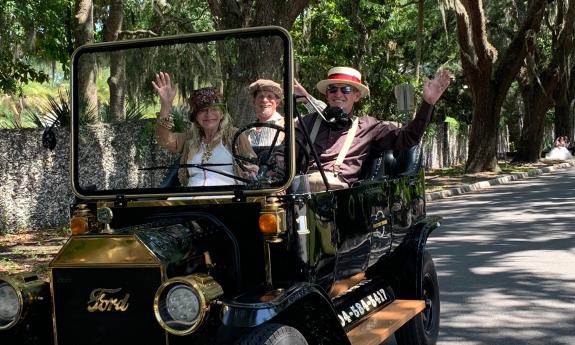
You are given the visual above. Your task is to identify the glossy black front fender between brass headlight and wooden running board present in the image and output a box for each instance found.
[221,282,349,344]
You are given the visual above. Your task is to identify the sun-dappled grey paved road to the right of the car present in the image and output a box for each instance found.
[428,168,575,345]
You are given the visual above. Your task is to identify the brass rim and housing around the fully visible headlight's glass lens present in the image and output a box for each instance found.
[154,274,224,336]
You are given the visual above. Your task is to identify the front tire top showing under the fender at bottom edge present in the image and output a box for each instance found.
[236,323,308,345]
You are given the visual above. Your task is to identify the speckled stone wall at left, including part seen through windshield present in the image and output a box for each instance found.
[0,123,174,233]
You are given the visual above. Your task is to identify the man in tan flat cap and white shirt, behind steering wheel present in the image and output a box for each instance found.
[248,79,284,146]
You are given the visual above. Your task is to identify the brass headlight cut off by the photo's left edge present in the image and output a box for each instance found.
[0,274,48,330]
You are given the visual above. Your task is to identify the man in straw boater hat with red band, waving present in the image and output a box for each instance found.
[294,67,450,188]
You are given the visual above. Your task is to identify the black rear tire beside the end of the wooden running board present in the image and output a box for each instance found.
[395,250,440,345]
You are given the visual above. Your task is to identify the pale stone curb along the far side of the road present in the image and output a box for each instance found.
[425,160,575,202]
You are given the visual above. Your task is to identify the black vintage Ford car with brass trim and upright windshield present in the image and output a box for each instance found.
[0,27,439,345]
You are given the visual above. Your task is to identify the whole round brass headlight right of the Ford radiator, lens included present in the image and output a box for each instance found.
[154,274,224,335]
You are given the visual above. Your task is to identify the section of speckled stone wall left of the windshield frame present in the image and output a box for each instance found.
[0,128,74,232]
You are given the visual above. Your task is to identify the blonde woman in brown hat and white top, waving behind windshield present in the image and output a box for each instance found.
[152,72,257,187]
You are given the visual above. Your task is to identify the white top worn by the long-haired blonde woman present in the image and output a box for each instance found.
[187,141,237,187]
